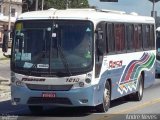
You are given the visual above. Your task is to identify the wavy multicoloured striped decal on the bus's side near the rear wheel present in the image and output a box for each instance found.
[118,53,155,94]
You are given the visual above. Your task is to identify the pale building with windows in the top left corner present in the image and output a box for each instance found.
[0,0,22,44]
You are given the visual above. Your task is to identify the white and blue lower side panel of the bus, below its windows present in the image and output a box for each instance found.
[100,51,155,100]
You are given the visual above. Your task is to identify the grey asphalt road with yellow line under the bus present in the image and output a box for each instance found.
[0,62,160,120]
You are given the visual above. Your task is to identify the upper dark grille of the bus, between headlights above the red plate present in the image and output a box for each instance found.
[26,84,73,91]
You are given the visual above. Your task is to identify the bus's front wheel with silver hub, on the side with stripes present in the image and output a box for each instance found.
[96,81,111,112]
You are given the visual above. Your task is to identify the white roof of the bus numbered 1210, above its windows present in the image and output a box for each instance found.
[17,9,155,23]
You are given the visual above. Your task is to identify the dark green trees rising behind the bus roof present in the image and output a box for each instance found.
[22,0,89,12]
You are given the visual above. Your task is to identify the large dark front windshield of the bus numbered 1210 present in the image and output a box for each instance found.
[11,20,94,76]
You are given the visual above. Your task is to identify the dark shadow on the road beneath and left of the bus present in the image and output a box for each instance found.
[0,97,144,118]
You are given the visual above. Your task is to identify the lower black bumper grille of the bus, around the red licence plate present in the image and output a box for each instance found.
[27,97,72,105]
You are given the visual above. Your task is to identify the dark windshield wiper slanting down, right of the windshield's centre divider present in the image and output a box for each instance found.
[57,44,72,76]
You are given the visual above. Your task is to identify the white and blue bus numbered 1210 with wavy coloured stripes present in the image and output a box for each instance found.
[8,9,156,112]
